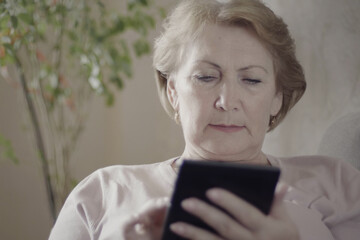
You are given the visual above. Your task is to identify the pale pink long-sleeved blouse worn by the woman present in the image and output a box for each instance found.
[49,156,360,240]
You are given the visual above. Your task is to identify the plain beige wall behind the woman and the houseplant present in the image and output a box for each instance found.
[0,0,360,240]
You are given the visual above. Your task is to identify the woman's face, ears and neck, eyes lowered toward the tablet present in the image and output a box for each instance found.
[168,25,282,161]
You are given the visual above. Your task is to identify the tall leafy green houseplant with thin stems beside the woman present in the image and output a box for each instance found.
[0,0,163,220]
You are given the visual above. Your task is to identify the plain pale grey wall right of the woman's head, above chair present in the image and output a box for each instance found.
[264,0,360,156]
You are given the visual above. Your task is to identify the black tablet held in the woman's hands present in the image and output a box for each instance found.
[162,160,280,240]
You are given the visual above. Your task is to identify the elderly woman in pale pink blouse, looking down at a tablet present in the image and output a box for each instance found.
[50,0,360,240]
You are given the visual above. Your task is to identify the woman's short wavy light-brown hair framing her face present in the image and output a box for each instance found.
[153,0,306,131]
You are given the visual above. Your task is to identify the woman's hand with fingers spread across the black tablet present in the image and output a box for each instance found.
[170,183,299,240]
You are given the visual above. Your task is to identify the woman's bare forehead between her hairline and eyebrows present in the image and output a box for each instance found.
[180,24,273,71]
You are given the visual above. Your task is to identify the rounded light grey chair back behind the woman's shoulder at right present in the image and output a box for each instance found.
[318,112,360,170]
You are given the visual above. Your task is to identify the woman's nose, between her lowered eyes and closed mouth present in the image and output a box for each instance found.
[215,80,241,111]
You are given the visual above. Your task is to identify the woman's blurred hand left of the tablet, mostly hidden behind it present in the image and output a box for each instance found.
[123,198,169,240]
